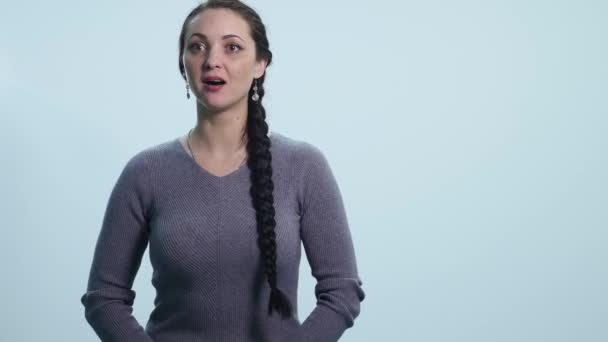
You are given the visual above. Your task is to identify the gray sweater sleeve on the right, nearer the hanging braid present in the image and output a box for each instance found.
[284,143,365,342]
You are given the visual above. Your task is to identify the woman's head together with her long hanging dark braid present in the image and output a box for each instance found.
[179,0,297,317]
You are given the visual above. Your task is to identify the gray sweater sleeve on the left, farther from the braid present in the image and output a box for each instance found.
[80,153,153,342]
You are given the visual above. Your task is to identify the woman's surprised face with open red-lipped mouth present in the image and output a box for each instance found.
[182,8,266,110]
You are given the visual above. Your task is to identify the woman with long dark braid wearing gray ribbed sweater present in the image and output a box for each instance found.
[81,0,365,342]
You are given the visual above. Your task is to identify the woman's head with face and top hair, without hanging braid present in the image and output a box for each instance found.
[179,0,272,110]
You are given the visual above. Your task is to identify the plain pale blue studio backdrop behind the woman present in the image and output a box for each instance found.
[0,0,608,342]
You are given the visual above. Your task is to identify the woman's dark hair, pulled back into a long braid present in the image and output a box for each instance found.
[179,0,293,317]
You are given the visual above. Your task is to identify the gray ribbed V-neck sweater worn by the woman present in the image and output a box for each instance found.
[80,132,365,342]
